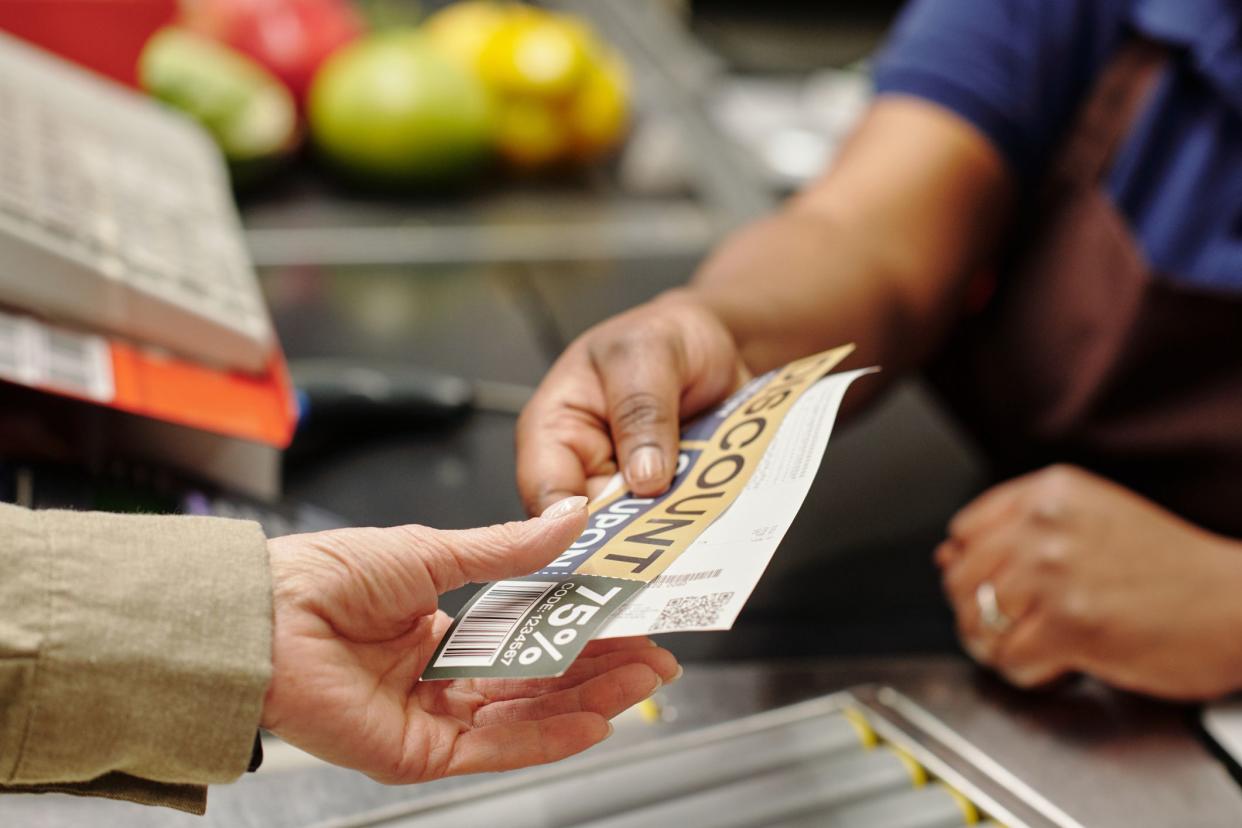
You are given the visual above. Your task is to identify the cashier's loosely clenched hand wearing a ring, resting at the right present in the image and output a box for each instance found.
[935,467,1242,699]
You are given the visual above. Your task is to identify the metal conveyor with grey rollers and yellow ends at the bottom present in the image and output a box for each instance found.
[315,688,1076,828]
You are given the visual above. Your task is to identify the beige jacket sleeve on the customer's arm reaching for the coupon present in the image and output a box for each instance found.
[0,504,272,813]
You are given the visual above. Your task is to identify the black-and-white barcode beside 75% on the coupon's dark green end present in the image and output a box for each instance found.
[432,581,558,667]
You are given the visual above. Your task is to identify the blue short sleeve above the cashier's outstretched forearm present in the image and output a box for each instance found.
[874,0,1129,181]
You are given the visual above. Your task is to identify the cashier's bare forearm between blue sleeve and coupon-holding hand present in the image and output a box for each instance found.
[689,99,1012,372]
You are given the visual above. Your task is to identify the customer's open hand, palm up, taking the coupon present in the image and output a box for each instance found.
[255,498,679,783]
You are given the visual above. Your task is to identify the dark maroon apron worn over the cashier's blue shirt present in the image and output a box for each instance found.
[932,41,1242,536]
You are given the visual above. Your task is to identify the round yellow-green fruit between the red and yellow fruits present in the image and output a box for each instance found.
[308,30,493,182]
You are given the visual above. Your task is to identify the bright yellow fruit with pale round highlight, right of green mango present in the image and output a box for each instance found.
[478,11,591,99]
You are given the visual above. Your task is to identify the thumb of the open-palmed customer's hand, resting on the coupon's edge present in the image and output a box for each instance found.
[424,495,586,593]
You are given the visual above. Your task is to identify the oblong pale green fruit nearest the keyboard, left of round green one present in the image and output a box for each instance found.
[138,26,298,165]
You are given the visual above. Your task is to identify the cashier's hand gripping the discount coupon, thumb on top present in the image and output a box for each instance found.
[518,290,746,514]
